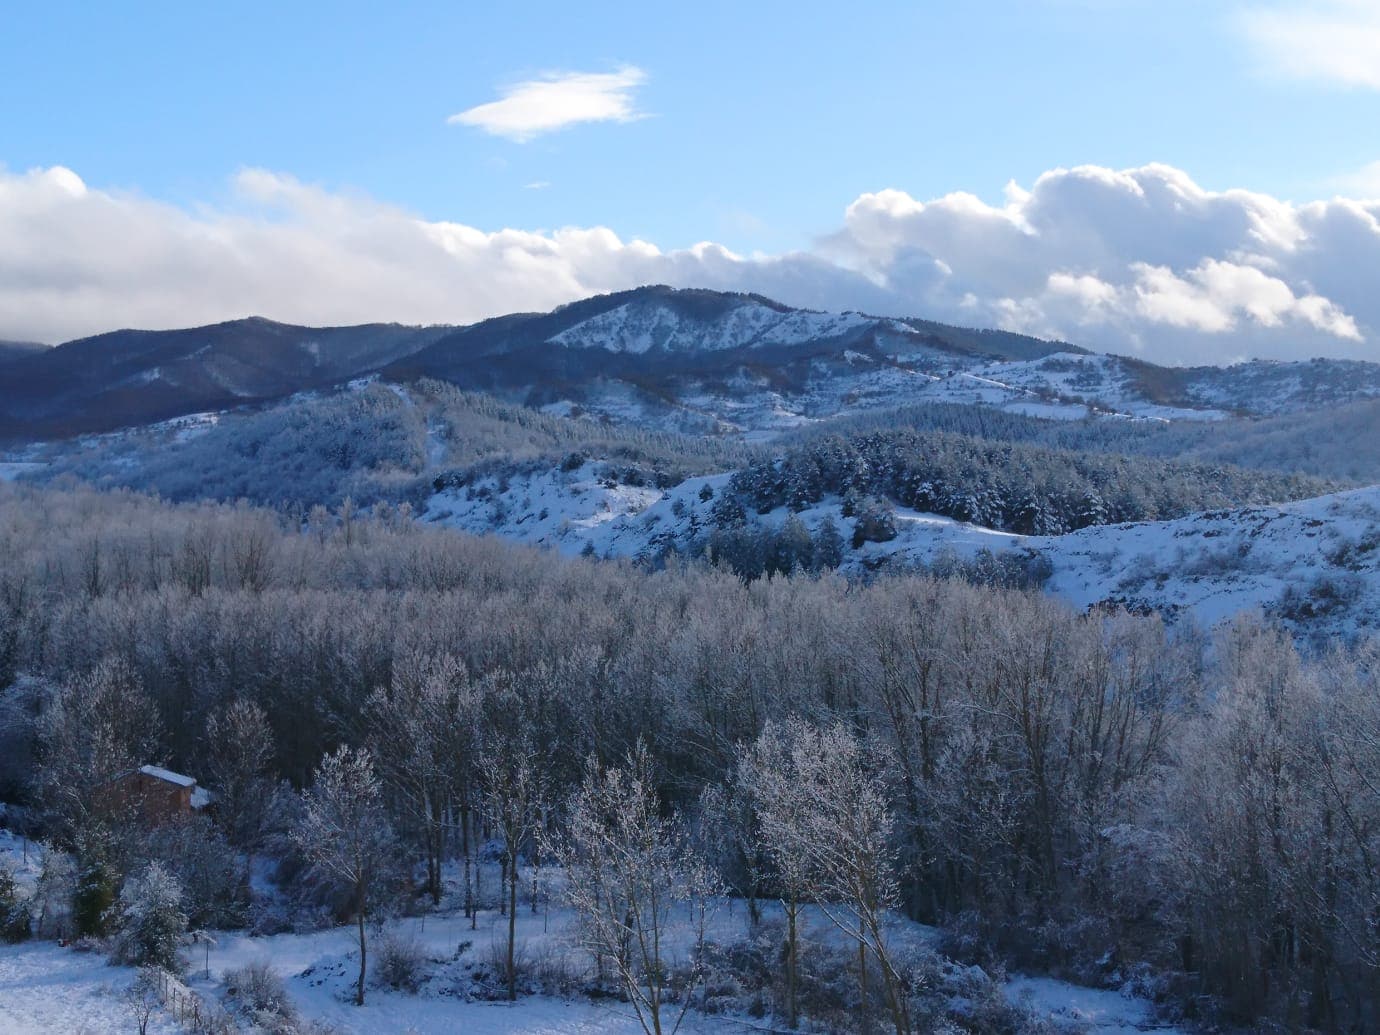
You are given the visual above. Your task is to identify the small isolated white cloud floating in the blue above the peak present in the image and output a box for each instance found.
[447,65,647,142]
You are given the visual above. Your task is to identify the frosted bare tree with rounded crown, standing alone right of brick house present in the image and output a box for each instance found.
[293,747,396,1006]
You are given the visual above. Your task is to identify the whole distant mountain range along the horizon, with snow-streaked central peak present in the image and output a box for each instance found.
[8,286,1380,444]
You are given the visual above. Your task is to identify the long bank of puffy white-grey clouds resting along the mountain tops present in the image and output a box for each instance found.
[0,166,1380,363]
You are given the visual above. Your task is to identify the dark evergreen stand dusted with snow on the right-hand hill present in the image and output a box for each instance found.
[731,429,1334,535]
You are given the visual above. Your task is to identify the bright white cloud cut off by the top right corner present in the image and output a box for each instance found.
[1239,0,1380,90]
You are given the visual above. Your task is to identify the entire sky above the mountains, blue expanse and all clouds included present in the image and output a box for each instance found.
[0,0,1380,363]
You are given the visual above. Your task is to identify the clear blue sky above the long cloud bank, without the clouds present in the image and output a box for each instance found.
[0,0,1380,364]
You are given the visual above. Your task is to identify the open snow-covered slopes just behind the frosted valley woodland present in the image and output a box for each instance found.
[425,464,1380,636]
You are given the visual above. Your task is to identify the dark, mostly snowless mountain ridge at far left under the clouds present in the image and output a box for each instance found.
[0,317,440,440]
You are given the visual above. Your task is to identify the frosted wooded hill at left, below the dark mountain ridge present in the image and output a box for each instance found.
[35,381,756,508]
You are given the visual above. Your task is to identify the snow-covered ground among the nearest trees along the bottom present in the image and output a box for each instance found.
[0,831,1174,1035]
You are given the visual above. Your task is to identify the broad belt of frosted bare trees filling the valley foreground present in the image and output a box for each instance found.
[0,487,1380,1031]
